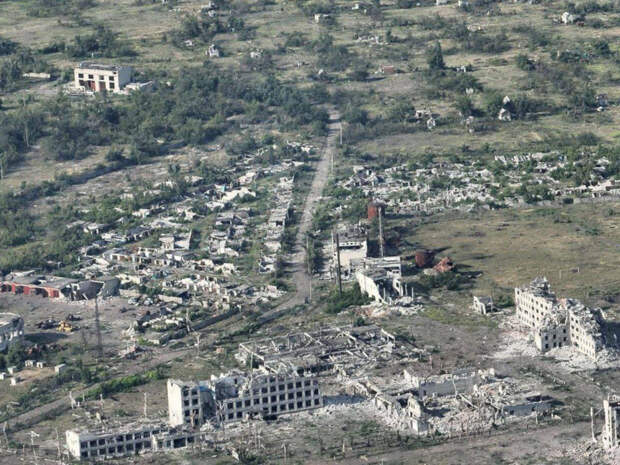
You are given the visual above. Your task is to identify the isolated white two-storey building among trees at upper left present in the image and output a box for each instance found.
[73,62,132,93]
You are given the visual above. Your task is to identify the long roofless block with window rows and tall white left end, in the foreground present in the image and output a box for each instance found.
[168,373,323,427]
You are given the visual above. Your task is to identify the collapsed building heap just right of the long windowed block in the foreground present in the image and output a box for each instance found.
[348,369,552,435]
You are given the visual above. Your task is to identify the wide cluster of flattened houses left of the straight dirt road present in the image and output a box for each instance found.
[0,146,312,344]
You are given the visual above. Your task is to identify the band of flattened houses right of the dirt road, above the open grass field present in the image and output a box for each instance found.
[341,153,620,215]
